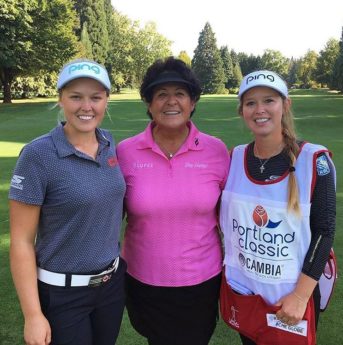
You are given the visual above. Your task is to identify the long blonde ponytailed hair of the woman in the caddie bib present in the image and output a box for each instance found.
[238,94,301,216]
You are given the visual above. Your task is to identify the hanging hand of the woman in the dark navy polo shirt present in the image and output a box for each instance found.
[24,314,51,345]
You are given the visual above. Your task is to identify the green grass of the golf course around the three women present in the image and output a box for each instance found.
[0,90,343,345]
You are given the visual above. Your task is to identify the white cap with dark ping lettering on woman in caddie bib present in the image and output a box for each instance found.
[238,70,288,98]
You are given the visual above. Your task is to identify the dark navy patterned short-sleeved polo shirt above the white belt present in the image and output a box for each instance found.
[9,124,125,273]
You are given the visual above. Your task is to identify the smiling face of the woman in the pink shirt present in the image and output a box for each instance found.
[148,84,195,129]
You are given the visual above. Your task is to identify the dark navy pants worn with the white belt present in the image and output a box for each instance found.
[38,259,126,345]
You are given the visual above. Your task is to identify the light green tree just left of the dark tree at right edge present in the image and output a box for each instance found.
[314,38,339,86]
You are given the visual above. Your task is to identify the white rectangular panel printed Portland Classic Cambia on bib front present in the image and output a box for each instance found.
[225,192,310,284]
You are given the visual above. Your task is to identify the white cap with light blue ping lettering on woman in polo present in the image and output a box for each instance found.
[57,59,111,91]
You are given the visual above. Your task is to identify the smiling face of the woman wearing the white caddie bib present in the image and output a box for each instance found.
[241,86,290,137]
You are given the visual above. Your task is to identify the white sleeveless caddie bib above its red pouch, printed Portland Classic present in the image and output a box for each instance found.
[220,143,334,304]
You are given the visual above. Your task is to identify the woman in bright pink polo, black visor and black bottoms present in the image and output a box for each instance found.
[117,57,229,345]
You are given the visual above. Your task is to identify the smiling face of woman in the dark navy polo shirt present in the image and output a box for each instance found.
[59,78,107,135]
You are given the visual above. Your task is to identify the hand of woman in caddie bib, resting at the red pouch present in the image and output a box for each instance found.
[276,292,308,326]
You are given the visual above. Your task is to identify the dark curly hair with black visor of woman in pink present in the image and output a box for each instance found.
[140,56,202,103]
